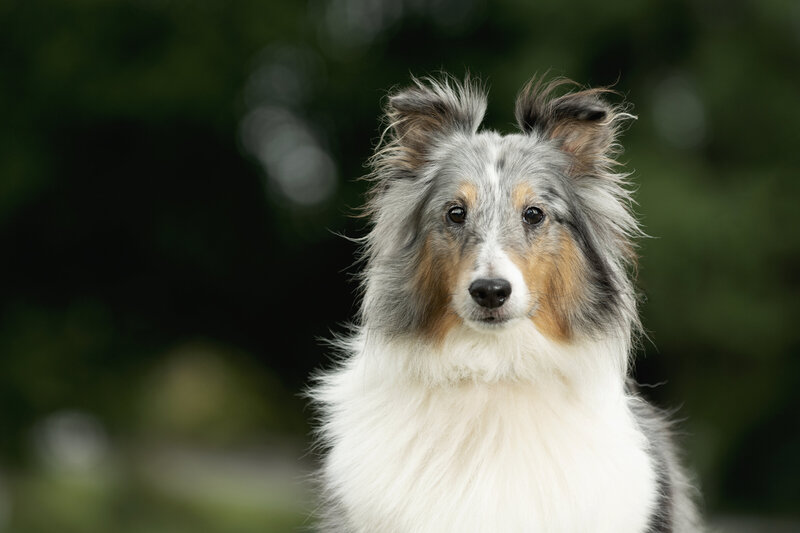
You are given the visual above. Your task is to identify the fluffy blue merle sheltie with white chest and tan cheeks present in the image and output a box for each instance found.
[310,76,703,533]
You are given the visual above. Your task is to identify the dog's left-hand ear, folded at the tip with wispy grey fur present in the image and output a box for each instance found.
[376,77,486,169]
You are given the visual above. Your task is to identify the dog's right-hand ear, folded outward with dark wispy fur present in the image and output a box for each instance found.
[515,78,634,173]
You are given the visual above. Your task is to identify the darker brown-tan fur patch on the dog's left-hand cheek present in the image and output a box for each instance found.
[416,240,461,344]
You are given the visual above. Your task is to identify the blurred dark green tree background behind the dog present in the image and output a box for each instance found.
[0,0,800,533]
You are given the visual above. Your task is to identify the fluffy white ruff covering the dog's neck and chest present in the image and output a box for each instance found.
[313,320,657,533]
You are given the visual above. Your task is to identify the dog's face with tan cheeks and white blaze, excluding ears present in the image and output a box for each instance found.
[418,133,587,338]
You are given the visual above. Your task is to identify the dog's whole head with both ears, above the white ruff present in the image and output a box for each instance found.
[362,75,638,342]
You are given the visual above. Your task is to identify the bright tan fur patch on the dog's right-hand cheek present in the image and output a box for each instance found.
[521,233,581,342]
